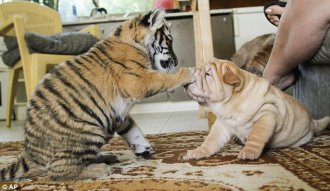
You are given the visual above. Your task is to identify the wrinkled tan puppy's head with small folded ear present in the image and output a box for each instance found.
[185,59,243,106]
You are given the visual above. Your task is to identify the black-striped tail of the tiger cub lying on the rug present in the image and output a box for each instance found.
[0,154,30,182]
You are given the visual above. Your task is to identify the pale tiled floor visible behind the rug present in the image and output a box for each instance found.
[0,111,208,142]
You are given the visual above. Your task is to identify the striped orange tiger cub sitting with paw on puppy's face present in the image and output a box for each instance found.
[0,9,193,181]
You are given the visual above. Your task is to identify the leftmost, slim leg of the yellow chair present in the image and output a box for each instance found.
[6,68,21,127]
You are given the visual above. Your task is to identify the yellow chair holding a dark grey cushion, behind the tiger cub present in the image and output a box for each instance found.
[0,2,101,127]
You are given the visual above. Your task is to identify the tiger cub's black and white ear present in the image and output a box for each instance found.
[141,9,165,31]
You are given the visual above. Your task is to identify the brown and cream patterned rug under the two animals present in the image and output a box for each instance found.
[0,130,330,191]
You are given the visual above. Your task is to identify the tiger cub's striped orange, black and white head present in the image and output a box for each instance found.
[115,9,178,73]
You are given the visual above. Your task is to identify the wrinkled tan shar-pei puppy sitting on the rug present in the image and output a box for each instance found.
[185,59,330,160]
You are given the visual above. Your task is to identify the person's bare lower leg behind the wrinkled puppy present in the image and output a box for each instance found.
[263,0,330,89]
